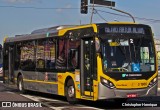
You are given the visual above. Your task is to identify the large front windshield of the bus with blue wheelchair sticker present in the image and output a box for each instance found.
[102,36,155,72]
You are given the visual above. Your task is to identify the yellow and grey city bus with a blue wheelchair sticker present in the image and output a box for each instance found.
[3,22,158,104]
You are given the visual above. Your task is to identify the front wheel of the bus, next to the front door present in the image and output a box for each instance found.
[66,79,78,104]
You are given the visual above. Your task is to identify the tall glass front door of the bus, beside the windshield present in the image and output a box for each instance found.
[81,38,95,97]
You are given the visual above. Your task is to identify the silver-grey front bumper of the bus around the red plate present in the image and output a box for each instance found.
[98,83,158,100]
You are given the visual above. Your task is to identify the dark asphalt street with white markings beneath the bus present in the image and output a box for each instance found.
[0,78,160,110]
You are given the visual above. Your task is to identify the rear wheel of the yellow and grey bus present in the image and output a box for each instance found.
[17,75,26,94]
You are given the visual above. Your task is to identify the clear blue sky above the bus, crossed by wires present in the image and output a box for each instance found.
[0,0,160,44]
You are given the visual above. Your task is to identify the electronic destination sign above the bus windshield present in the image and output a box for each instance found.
[105,26,145,34]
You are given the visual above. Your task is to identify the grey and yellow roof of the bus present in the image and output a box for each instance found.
[4,22,151,43]
